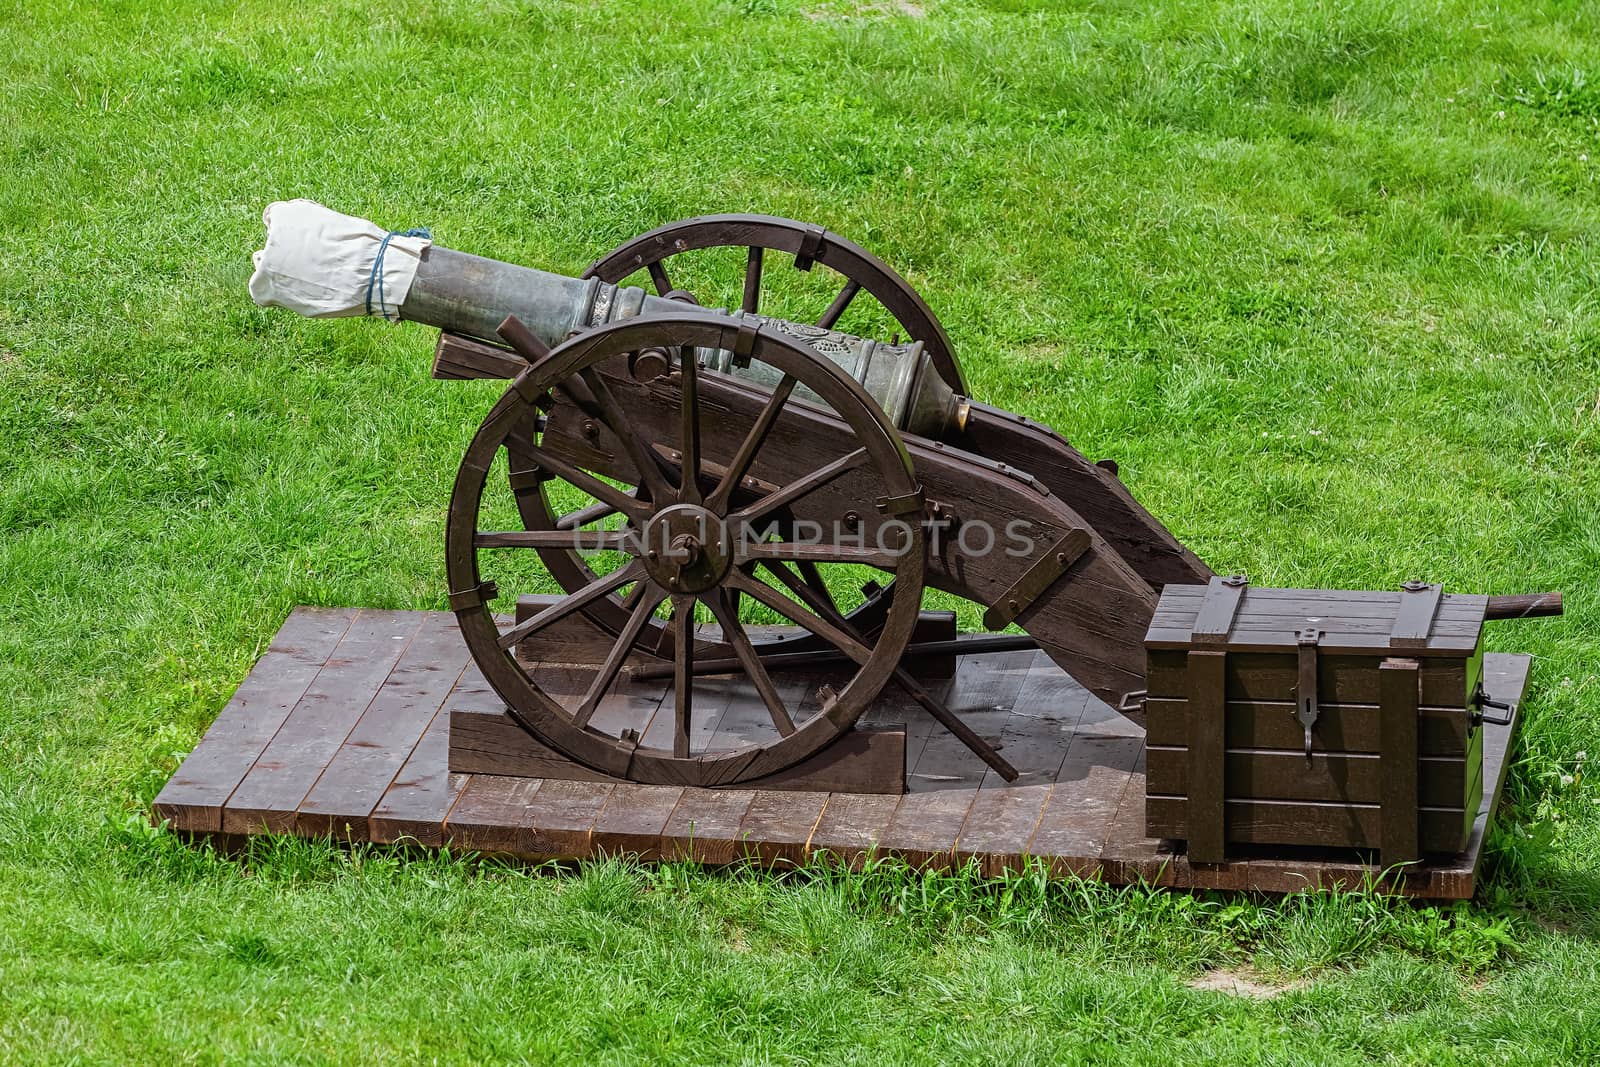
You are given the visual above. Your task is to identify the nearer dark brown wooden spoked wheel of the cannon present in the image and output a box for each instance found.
[446,314,925,785]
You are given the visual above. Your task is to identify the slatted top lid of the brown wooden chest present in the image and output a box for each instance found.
[1144,576,1488,659]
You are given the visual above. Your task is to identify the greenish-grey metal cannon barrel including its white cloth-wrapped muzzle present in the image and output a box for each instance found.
[250,200,968,438]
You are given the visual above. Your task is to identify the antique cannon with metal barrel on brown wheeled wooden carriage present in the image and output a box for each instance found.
[251,202,1558,819]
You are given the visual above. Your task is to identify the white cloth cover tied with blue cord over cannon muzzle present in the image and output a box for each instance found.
[250,200,434,320]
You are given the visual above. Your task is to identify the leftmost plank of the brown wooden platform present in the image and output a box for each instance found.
[154,608,357,833]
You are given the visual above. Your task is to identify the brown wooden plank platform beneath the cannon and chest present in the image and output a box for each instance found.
[154,608,1528,899]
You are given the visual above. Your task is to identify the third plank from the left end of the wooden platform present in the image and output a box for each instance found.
[294,614,469,841]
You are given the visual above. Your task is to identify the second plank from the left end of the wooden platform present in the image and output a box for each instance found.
[222,611,424,833]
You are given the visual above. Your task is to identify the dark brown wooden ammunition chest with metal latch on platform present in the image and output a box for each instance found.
[1146,577,1488,867]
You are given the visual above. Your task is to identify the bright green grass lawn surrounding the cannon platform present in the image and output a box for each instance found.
[0,0,1600,1064]
